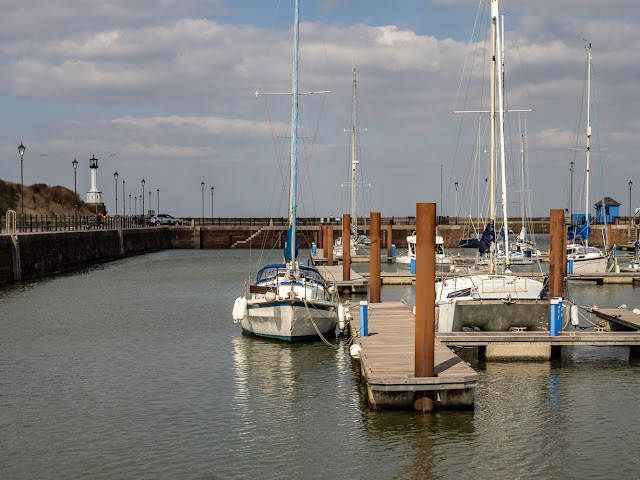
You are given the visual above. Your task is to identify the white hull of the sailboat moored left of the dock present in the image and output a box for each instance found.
[241,300,338,342]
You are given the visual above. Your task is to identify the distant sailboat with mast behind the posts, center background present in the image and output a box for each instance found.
[333,67,370,259]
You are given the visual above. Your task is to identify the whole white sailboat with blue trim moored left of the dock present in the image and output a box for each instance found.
[233,0,339,341]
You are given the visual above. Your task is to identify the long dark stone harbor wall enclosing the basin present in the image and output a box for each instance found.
[0,219,637,286]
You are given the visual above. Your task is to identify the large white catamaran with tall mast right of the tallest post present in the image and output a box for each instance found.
[435,0,548,332]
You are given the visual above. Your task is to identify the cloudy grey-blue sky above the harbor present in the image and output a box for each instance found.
[0,0,640,217]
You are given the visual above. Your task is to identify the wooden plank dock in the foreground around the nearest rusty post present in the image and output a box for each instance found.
[350,302,478,408]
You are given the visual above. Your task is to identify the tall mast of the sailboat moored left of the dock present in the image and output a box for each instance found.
[289,0,300,270]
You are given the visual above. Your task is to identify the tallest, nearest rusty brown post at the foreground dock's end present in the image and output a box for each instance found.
[413,203,436,412]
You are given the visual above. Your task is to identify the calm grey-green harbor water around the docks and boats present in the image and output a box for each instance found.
[0,250,640,480]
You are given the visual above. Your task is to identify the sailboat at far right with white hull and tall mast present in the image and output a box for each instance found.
[567,44,609,274]
